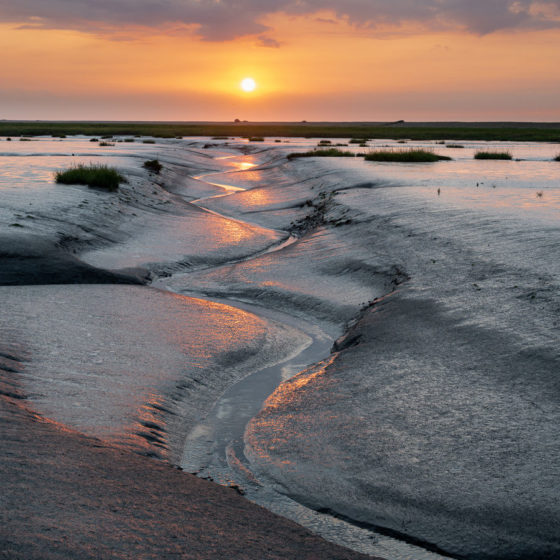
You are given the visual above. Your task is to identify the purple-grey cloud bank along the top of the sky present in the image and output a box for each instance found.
[0,0,560,40]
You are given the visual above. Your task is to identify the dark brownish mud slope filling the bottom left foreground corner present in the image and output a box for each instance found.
[0,396,378,560]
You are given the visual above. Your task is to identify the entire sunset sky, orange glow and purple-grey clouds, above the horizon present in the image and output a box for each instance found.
[0,0,560,121]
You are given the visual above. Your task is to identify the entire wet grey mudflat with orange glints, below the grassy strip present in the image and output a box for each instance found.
[0,140,560,560]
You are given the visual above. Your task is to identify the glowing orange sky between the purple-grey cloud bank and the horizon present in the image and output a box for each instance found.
[0,8,560,121]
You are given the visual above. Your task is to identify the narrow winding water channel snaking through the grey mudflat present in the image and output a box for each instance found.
[162,156,447,560]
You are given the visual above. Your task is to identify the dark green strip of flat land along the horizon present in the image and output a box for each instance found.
[0,120,560,142]
